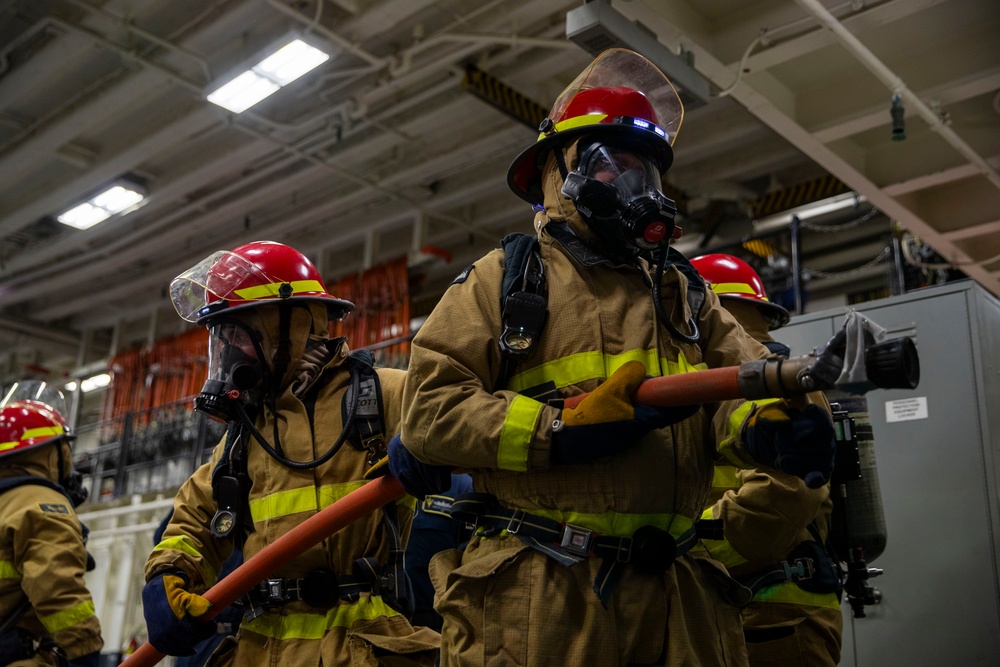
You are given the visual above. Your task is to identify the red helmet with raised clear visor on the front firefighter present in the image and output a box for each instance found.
[507,49,684,203]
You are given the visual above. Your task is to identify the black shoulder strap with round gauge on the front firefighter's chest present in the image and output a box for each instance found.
[495,233,548,388]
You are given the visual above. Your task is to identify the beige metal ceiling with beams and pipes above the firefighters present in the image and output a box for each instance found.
[0,0,1000,381]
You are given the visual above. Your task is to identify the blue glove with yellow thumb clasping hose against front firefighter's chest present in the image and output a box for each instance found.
[551,361,699,463]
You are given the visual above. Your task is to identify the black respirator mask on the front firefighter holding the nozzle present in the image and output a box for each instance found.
[562,141,677,256]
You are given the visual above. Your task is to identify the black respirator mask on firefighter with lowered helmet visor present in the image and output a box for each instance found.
[194,318,266,422]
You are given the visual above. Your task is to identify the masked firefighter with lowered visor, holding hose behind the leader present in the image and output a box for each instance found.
[142,241,438,666]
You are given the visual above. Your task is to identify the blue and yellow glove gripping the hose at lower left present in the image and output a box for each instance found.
[142,571,218,656]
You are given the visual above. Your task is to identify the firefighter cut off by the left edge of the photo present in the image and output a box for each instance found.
[0,382,104,667]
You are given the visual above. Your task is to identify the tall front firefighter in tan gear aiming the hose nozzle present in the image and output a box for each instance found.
[389,49,833,667]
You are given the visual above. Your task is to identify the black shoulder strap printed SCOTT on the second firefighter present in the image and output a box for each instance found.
[340,349,387,465]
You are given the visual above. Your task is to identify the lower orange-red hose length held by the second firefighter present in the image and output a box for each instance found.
[119,475,405,667]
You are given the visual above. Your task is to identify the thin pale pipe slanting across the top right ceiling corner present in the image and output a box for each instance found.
[795,0,1000,189]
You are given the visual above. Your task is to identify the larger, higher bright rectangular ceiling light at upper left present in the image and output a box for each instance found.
[208,39,330,113]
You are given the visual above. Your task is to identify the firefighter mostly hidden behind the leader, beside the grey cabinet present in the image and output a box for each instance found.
[691,254,843,667]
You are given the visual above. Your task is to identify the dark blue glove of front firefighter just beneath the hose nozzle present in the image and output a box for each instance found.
[744,403,837,489]
